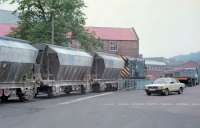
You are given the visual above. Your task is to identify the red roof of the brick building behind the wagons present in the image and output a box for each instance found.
[86,27,138,41]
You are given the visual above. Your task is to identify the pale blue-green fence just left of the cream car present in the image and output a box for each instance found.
[119,79,153,90]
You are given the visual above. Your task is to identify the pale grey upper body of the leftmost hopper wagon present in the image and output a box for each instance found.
[0,37,38,63]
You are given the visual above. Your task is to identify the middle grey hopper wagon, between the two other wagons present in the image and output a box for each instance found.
[35,44,93,96]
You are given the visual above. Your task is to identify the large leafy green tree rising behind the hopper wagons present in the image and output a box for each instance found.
[1,0,101,50]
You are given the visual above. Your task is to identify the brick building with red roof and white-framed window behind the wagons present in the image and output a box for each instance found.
[86,27,139,58]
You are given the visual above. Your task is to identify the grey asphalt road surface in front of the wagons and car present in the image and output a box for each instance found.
[0,87,200,128]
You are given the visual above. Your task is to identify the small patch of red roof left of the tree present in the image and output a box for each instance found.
[0,23,16,36]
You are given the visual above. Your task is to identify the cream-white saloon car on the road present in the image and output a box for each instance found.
[145,78,185,96]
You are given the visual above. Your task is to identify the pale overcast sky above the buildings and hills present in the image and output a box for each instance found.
[0,0,200,57]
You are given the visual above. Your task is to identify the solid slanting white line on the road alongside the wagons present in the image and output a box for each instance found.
[58,92,113,105]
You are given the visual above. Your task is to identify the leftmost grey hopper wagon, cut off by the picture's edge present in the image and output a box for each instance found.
[0,37,38,100]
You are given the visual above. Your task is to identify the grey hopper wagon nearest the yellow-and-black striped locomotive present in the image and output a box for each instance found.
[91,52,124,92]
